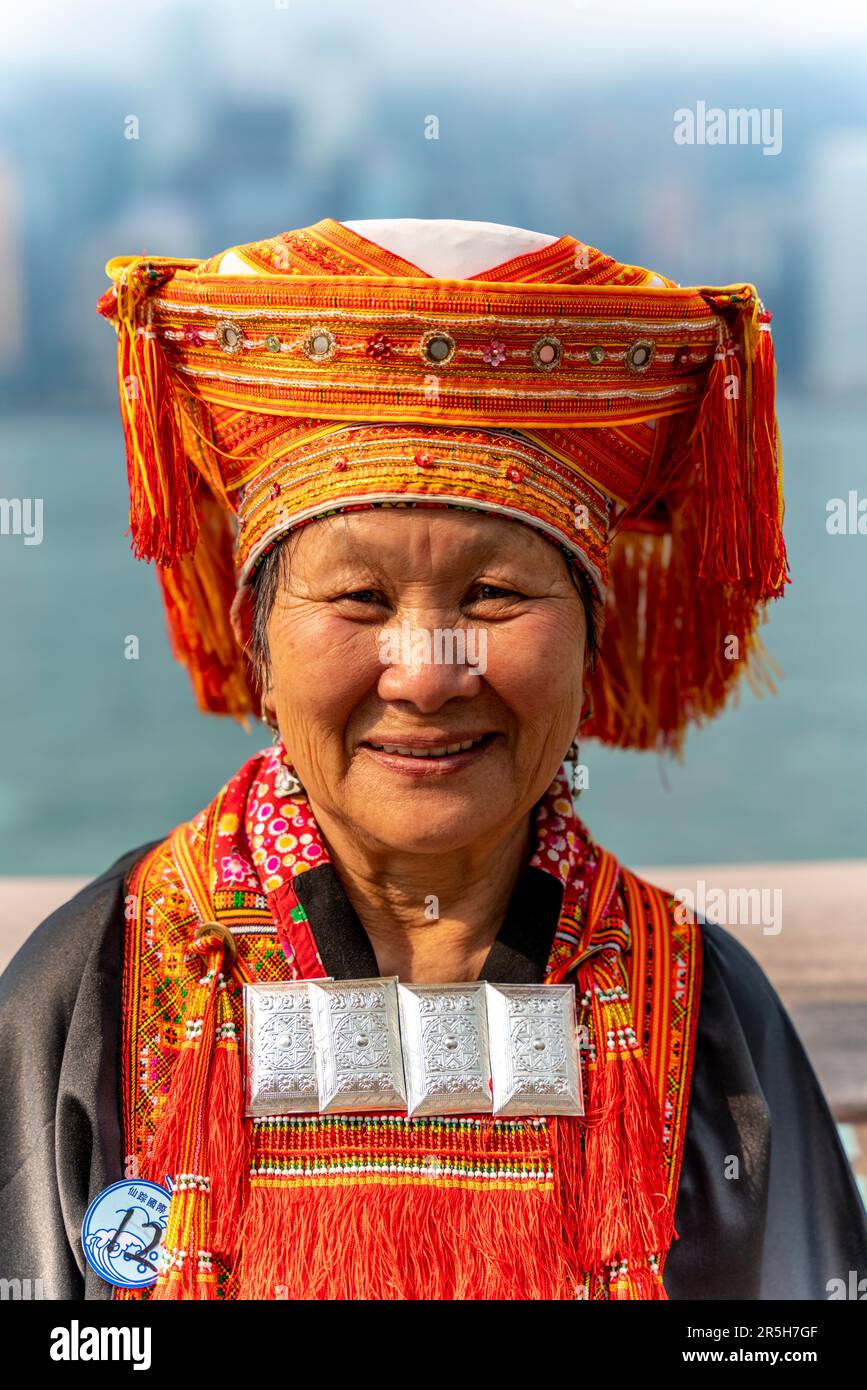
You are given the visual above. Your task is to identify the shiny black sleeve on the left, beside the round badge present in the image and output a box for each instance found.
[0,847,157,1298]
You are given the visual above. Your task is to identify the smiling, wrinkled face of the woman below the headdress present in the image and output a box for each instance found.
[265,507,585,853]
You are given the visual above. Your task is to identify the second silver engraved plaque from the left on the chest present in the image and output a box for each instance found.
[310,976,406,1115]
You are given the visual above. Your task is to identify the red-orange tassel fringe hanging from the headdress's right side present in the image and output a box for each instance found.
[584,300,789,752]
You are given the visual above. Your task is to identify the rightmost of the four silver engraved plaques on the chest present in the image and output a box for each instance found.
[486,984,584,1115]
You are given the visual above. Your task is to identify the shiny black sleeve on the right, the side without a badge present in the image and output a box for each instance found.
[663,924,867,1300]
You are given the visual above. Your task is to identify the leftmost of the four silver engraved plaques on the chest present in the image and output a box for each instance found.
[243,980,320,1115]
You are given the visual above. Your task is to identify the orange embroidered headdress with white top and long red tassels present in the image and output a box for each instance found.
[99,218,788,748]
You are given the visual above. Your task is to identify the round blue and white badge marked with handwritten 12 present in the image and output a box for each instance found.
[82,1177,171,1289]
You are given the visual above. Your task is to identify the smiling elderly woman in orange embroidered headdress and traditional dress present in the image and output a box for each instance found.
[0,218,867,1298]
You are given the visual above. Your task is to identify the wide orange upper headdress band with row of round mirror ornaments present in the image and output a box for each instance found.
[127,263,739,427]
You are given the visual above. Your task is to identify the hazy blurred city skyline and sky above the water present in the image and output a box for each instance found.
[0,0,867,409]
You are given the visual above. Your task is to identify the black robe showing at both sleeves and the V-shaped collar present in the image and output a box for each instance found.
[0,847,867,1300]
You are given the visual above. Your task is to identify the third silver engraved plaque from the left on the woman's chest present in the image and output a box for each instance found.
[397,984,492,1115]
